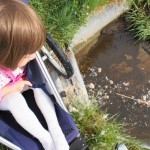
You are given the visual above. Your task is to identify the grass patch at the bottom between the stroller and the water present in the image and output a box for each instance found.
[69,97,144,150]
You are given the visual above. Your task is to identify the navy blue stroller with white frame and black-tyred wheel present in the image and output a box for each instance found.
[0,31,88,150]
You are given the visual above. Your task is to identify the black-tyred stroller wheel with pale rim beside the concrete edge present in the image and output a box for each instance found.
[41,33,74,79]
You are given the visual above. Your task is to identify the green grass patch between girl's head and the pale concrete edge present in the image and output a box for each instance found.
[30,0,109,46]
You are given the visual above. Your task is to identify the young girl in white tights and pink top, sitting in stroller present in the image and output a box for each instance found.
[0,0,69,150]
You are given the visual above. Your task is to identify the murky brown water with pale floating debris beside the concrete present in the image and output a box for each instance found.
[77,18,150,139]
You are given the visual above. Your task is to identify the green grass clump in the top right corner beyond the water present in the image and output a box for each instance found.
[125,0,150,42]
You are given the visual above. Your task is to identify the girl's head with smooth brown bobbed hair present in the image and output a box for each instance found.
[0,0,45,70]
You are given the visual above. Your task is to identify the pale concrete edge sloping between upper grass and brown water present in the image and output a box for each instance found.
[70,2,129,54]
